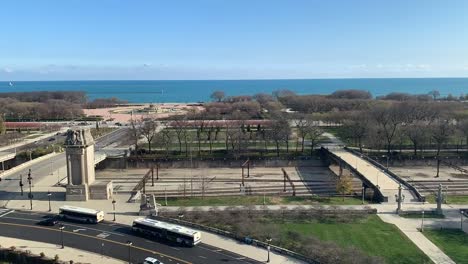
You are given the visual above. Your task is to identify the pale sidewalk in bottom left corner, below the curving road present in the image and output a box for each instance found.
[0,236,126,264]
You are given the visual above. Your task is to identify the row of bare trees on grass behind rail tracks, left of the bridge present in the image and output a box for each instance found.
[129,115,323,157]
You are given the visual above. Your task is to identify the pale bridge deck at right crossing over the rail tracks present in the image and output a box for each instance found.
[321,147,424,203]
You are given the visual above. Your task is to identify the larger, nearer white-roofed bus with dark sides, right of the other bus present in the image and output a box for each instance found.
[132,218,201,246]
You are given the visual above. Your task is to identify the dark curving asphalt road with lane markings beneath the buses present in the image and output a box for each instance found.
[0,210,261,264]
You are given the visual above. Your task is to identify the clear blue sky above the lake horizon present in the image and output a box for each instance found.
[0,0,468,81]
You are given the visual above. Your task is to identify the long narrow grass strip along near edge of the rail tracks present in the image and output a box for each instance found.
[167,196,368,206]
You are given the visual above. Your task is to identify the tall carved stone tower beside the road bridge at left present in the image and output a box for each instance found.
[65,128,95,201]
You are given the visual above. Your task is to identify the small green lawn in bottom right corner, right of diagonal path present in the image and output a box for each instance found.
[424,229,468,263]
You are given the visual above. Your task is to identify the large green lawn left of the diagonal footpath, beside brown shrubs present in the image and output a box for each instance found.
[277,215,432,264]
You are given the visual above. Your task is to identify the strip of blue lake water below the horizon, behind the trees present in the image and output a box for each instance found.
[0,78,468,103]
